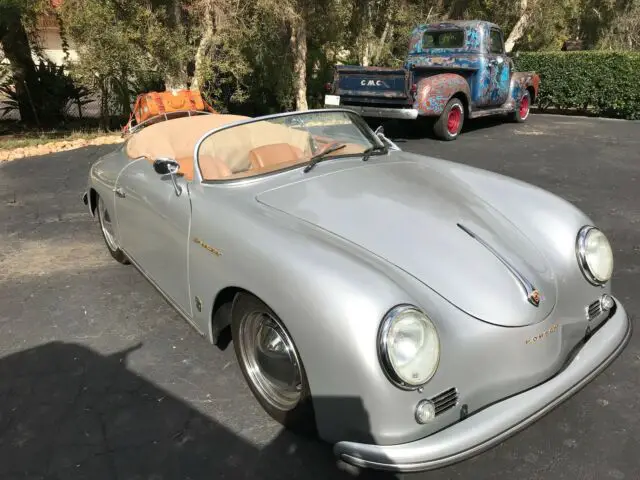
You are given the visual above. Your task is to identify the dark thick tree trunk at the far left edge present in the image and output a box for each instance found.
[0,11,38,123]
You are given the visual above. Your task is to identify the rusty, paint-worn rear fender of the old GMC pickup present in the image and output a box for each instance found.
[413,73,471,116]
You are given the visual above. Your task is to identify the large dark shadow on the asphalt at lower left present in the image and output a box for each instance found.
[0,342,396,480]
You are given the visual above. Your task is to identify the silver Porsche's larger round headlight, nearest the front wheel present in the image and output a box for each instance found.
[378,305,440,389]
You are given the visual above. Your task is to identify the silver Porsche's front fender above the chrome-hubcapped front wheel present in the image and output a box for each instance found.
[189,187,468,444]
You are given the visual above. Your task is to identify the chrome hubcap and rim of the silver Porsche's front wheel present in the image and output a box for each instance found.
[238,312,302,411]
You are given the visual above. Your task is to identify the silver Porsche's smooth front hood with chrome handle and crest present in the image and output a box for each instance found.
[257,161,556,327]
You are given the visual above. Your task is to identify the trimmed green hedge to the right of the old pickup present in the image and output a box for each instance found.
[514,51,640,119]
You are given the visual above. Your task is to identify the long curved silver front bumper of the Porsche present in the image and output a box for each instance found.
[334,299,632,472]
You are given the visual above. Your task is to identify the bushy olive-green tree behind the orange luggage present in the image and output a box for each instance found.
[60,0,191,122]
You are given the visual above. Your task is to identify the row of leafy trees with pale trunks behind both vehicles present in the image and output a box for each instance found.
[0,0,640,122]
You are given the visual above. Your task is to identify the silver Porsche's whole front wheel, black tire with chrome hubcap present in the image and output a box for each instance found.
[231,293,317,436]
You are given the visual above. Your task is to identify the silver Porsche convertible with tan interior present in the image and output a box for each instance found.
[83,109,631,471]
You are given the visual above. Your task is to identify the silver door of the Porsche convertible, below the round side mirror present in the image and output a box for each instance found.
[115,159,192,317]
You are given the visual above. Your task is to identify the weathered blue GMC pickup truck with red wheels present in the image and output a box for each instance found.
[324,21,540,140]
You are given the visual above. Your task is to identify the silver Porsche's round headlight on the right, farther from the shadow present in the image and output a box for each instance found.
[576,226,613,285]
